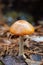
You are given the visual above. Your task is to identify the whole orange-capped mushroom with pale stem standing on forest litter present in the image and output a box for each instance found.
[10,20,34,56]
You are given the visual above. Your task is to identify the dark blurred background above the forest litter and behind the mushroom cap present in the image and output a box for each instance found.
[0,0,43,25]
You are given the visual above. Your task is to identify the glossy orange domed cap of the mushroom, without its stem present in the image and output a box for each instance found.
[10,20,34,36]
